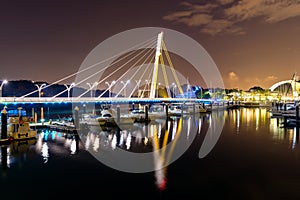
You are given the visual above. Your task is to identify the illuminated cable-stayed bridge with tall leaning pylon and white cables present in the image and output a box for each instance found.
[0,32,212,103]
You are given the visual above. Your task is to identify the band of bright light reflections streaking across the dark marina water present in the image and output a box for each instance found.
[1,108,299,194]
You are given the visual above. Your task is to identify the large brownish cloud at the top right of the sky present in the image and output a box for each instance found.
[163,0,300,35]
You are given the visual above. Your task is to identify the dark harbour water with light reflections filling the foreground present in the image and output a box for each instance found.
[0,108,300,199]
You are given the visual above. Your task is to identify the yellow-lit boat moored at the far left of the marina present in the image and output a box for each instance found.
[7,116,37,140]
